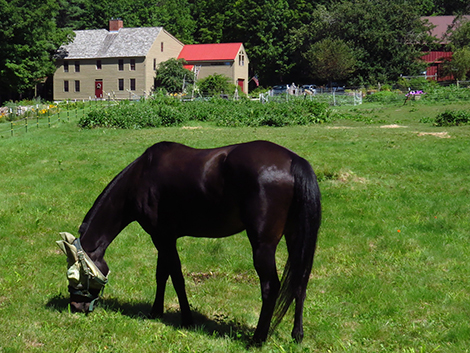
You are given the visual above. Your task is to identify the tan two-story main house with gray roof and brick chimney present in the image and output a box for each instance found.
[54,20,184,101]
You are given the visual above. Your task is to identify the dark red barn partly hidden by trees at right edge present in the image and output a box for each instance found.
[421,16,470,81]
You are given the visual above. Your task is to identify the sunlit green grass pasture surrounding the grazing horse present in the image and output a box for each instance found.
[0,100,470,353]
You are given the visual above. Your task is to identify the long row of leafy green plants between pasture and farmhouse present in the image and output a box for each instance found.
[79,97,331,129]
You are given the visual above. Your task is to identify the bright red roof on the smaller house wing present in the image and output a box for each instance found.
[178,43,242,62]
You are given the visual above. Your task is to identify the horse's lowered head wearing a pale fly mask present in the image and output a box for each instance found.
[57,232,108,312]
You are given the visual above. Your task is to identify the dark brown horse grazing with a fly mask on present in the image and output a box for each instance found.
[58,141,321,342]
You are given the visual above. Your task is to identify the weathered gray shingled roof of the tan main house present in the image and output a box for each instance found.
[59,27,163,59]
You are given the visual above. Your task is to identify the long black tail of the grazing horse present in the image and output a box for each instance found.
[270,155,321,332]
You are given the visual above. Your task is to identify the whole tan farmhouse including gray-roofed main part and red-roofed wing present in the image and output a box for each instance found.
[53,19,249,101]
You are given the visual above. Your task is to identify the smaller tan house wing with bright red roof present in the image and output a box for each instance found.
[178,43,249,93]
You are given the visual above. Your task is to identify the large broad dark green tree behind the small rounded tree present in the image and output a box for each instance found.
[291,0,431,84]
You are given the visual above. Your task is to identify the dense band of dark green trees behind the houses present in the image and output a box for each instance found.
[0,0,470,101]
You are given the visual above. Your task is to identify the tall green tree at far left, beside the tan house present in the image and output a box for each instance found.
[0,0,73,101]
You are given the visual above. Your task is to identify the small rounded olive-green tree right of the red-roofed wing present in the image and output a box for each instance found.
[305,38,356,87]
